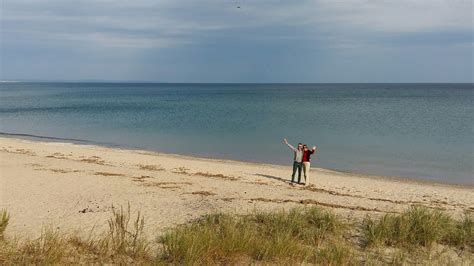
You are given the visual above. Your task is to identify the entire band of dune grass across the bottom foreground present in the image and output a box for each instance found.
[0,206,474,265]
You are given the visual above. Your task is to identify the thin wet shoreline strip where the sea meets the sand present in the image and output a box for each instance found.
[0,132,474,189]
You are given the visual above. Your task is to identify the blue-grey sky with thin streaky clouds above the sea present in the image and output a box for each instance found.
[0,0,474,83]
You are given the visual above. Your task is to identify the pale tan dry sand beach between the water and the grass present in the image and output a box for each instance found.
[0,138,474,236]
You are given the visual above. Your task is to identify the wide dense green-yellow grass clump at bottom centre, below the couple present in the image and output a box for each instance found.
[160,207,350,264]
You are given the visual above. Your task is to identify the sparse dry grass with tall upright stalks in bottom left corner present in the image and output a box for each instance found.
[0,206,151,264]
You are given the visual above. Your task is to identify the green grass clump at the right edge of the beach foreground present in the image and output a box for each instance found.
[363,206,473,248]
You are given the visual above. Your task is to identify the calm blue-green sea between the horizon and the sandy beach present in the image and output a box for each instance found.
[0,83,474,184]
